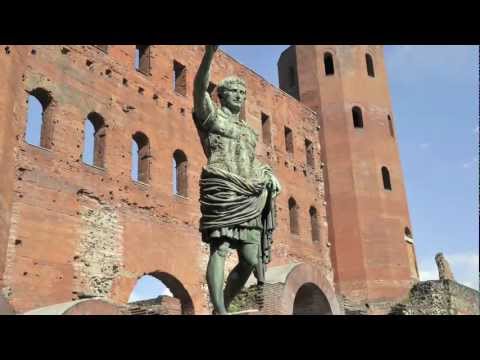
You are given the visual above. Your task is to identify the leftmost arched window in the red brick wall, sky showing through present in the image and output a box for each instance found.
[25,88,53,149]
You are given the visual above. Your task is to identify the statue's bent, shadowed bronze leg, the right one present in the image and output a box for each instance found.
[224,240,258,309]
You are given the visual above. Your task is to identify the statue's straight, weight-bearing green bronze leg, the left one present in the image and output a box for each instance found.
[207,241,230,315]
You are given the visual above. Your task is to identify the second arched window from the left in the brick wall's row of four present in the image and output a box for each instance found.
[83,112,106,168]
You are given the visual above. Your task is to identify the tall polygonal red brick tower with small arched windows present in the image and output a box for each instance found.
[278,45,418,313]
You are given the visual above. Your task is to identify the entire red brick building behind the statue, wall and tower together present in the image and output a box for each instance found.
[0,45,418,314]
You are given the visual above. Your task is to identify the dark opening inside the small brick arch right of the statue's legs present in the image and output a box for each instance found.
[293,283,332,315]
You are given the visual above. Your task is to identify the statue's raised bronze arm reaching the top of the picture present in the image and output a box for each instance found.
[193,45,218,126]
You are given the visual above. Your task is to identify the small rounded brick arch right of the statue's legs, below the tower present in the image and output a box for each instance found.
[282,263,343,315]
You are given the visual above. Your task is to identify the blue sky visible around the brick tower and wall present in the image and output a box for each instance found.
[27,45,479,300]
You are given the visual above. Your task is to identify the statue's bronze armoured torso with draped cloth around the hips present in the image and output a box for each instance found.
[198,108,276,282]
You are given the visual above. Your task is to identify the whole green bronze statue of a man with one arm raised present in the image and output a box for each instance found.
[194,45,281,314]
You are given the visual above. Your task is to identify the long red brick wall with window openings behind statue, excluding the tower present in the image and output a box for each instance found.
[0,45,333,314]
